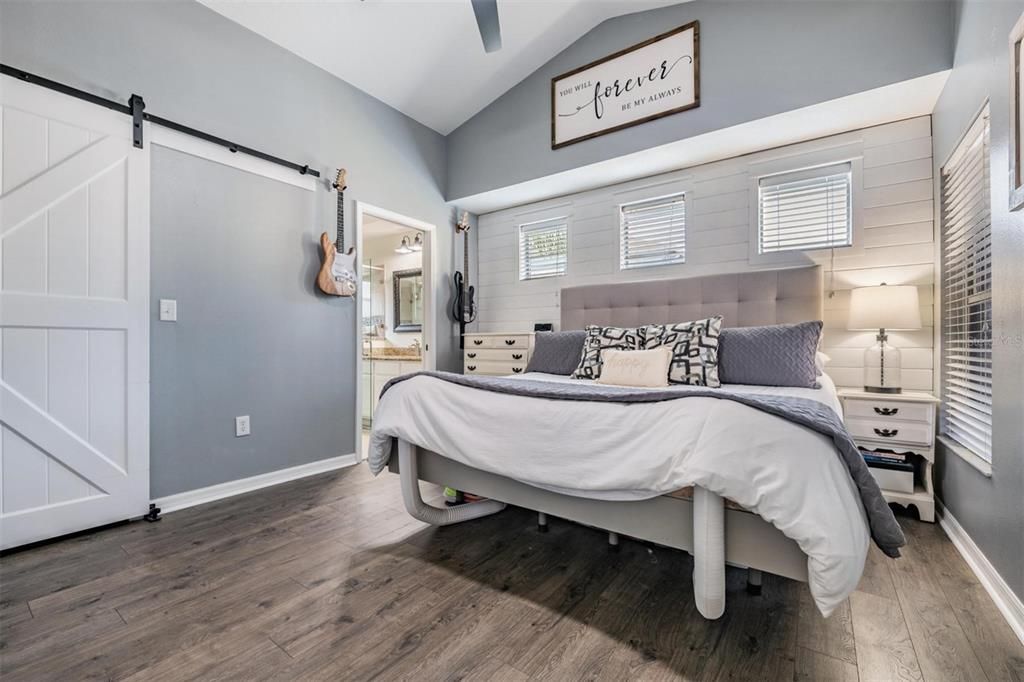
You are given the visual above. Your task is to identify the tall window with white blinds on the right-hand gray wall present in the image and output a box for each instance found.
[940,106,992,462]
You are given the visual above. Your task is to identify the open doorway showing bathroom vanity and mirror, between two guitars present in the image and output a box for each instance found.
[356,202,436,457]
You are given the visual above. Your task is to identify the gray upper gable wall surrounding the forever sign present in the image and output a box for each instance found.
[446,0,951,200]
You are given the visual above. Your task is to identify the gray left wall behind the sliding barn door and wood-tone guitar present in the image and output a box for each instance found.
[0,2,461,497]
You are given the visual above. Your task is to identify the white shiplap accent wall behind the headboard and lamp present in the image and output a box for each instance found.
[475,116,936,390]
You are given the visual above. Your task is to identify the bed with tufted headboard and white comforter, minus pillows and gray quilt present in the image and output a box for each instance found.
[370,267,888,619]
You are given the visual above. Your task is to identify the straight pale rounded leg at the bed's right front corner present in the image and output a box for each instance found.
[693,485,725,621]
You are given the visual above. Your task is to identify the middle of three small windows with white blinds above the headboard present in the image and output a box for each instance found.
[618,194,686,270]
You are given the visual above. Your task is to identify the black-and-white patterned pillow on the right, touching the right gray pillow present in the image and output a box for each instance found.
[640,315,722,388]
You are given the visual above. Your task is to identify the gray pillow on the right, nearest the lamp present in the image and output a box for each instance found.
[718,321,821,388]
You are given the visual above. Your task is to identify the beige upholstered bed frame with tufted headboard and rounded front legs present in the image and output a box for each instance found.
[389,266,822,620]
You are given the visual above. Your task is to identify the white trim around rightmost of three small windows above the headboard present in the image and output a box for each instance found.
[748,156,864,265]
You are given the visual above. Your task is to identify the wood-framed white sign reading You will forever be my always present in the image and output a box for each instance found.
[551,22,700,150]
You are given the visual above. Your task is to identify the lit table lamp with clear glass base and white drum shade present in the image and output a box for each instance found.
[847,283,921,393]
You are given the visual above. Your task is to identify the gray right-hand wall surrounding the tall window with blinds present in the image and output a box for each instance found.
[932,0,1024,599]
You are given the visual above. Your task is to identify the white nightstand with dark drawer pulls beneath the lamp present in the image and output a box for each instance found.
[839,389,939,523]
